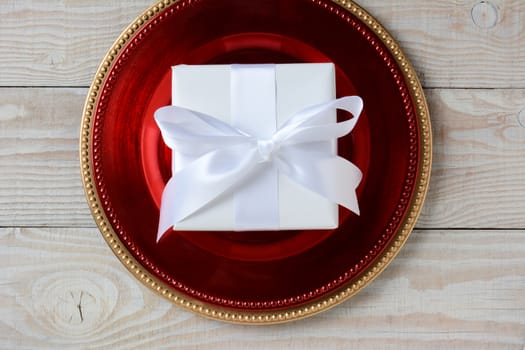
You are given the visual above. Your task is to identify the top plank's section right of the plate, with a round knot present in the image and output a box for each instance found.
[358,0,525,88]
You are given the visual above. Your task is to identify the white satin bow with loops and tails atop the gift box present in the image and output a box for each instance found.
[155,66,363,240]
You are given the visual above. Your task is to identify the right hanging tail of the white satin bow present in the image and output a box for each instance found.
[278,148,363,215]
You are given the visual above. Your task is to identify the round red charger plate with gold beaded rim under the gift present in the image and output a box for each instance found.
[80,0,431,323]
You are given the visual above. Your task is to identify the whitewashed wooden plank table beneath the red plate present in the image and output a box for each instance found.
[0,0,525,350]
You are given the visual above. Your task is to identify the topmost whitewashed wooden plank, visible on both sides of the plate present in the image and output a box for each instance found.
[0,0,525,88]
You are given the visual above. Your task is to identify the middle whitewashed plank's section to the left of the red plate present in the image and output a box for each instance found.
[0,89,89,226]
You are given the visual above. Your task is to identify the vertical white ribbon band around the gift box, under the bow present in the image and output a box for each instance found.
[230,64,281,231]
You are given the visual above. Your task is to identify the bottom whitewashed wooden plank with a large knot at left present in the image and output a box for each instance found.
[0,228,525,350]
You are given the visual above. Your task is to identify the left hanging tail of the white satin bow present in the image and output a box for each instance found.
[157,144,259,242]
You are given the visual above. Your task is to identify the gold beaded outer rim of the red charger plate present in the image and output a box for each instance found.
[79,0,432,324]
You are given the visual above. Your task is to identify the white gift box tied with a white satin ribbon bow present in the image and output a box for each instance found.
[156,63,362,238]
